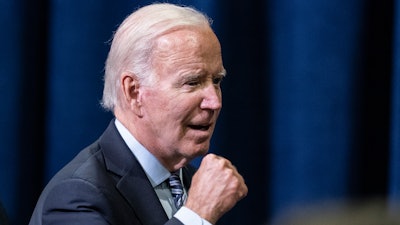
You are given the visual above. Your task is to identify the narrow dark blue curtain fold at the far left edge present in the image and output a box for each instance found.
[0,1,23,221]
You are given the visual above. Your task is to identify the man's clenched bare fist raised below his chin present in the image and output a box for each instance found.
[185,154,248,224]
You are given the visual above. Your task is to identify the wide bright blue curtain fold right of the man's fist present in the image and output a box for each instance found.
[267,0,365,212]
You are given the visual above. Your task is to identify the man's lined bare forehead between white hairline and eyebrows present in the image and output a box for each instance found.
[152,28,224,78]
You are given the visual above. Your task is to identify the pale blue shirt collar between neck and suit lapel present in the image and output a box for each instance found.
[115,119,171,187]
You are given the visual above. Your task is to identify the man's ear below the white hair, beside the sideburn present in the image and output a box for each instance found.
[121,73,142,116]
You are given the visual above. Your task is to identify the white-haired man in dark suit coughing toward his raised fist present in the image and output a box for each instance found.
[30,4,247,225]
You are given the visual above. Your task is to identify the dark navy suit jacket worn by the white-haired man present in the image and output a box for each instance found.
[29,120,195,225]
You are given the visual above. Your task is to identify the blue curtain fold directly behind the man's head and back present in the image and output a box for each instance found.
[45,1,122,181]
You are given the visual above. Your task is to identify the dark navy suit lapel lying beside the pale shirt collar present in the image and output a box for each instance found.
[99,120,168,225]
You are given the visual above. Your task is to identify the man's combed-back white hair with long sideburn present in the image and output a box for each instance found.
[102,3,211,111]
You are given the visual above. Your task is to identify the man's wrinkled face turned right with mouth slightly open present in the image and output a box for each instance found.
[140,29,225,162]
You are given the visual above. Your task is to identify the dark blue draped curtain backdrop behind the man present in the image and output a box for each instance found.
[0,0,400,225]
